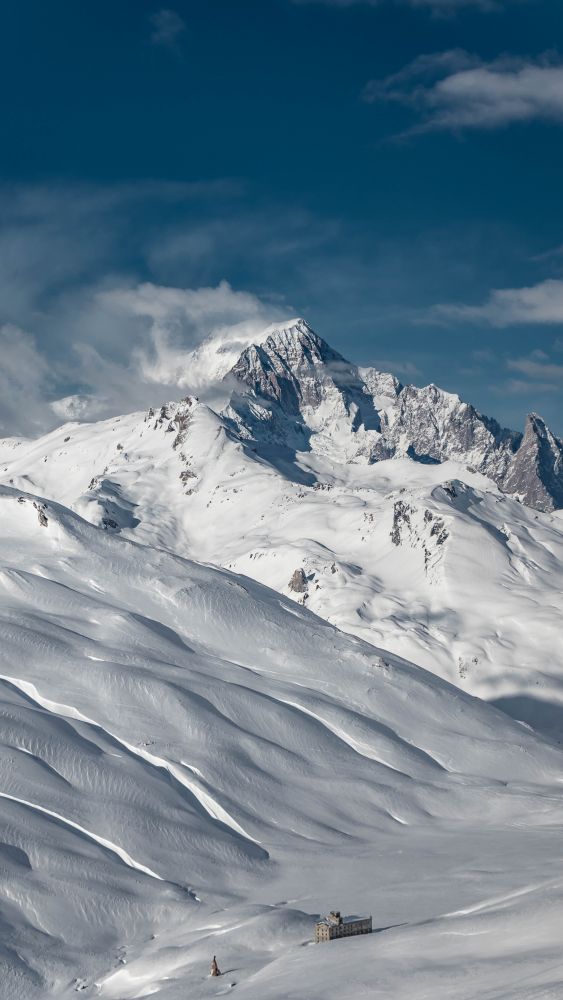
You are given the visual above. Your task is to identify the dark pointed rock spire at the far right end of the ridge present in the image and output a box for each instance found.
[503,413,563,511]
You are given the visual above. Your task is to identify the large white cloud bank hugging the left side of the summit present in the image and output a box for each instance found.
[0,282,288,436]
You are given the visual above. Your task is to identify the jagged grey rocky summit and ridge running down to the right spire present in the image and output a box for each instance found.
[225,320,563,510]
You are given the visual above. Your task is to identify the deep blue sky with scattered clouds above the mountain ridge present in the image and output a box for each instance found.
[0,0,563,434]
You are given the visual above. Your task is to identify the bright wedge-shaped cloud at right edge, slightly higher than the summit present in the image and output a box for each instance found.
[431,278,563,327]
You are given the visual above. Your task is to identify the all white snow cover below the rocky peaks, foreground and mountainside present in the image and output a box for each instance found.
[0,318,563,1000]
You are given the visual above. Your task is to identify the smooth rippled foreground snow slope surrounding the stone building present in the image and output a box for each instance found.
[0,487,563,1000]
